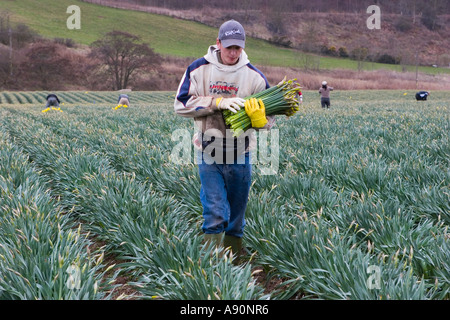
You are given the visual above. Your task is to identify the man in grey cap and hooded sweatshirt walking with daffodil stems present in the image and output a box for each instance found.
[174,20,274,262]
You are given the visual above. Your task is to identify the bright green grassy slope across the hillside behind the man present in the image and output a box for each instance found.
[2,0,450,73]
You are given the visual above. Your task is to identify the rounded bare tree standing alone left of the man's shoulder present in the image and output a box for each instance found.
[91,31,160,90]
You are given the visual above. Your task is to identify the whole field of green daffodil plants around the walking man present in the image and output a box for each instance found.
[0,91,450,300]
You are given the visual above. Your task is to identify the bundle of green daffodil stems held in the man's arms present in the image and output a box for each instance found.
[223,78,302,136]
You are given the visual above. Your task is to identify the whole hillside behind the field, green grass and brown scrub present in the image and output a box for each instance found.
[0,0,450,90]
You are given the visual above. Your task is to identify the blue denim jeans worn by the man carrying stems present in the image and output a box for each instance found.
[198,152,252,238]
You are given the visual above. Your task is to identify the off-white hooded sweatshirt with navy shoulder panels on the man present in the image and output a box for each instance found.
[174,46,274,152]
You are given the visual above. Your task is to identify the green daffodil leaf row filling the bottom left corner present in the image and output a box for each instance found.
[0,115,115,300]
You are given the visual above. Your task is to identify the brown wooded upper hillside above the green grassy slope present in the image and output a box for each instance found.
[83,0,450,67]
